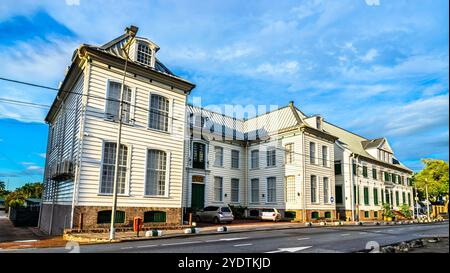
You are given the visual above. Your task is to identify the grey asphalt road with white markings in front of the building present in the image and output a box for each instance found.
[0,222,449,253]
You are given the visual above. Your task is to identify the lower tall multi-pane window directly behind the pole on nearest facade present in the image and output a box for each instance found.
[100,142,128,194]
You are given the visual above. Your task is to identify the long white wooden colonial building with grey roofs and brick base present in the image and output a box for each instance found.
[39,27,412,234]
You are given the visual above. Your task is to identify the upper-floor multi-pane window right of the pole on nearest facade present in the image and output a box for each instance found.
[148,94,169,132]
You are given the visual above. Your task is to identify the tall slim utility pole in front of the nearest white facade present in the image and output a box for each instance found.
[109,26,138,240]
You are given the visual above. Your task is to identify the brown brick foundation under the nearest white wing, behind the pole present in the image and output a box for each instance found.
[73,206,182,230]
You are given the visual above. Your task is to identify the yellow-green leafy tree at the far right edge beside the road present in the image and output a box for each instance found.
[413,159,449,200]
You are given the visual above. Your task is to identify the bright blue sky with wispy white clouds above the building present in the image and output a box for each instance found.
[0,0,449,189]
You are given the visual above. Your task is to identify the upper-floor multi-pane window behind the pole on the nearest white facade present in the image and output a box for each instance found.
[105,81,132,123]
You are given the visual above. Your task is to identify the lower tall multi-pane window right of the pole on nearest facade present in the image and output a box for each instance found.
[145,150,167,196]
